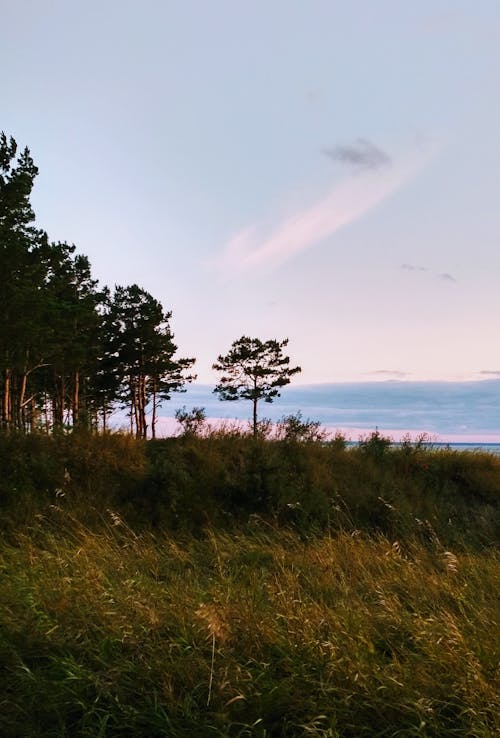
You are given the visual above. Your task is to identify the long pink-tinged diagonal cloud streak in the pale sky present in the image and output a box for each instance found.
[222,145,430,272]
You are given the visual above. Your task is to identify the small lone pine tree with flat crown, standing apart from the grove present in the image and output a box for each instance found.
[213,336,301,435]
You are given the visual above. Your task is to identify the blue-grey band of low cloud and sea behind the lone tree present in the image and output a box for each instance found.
[158,379,500,452]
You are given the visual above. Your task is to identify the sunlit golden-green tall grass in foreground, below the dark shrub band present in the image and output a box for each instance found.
[0,510,500,738]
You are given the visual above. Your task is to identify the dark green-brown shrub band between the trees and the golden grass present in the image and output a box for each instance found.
[0,432,500,547]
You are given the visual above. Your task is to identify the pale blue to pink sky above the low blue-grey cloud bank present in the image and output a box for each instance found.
[0,0,500,400]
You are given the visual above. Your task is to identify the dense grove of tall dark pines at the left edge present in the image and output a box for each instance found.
[0,133,194,438]
